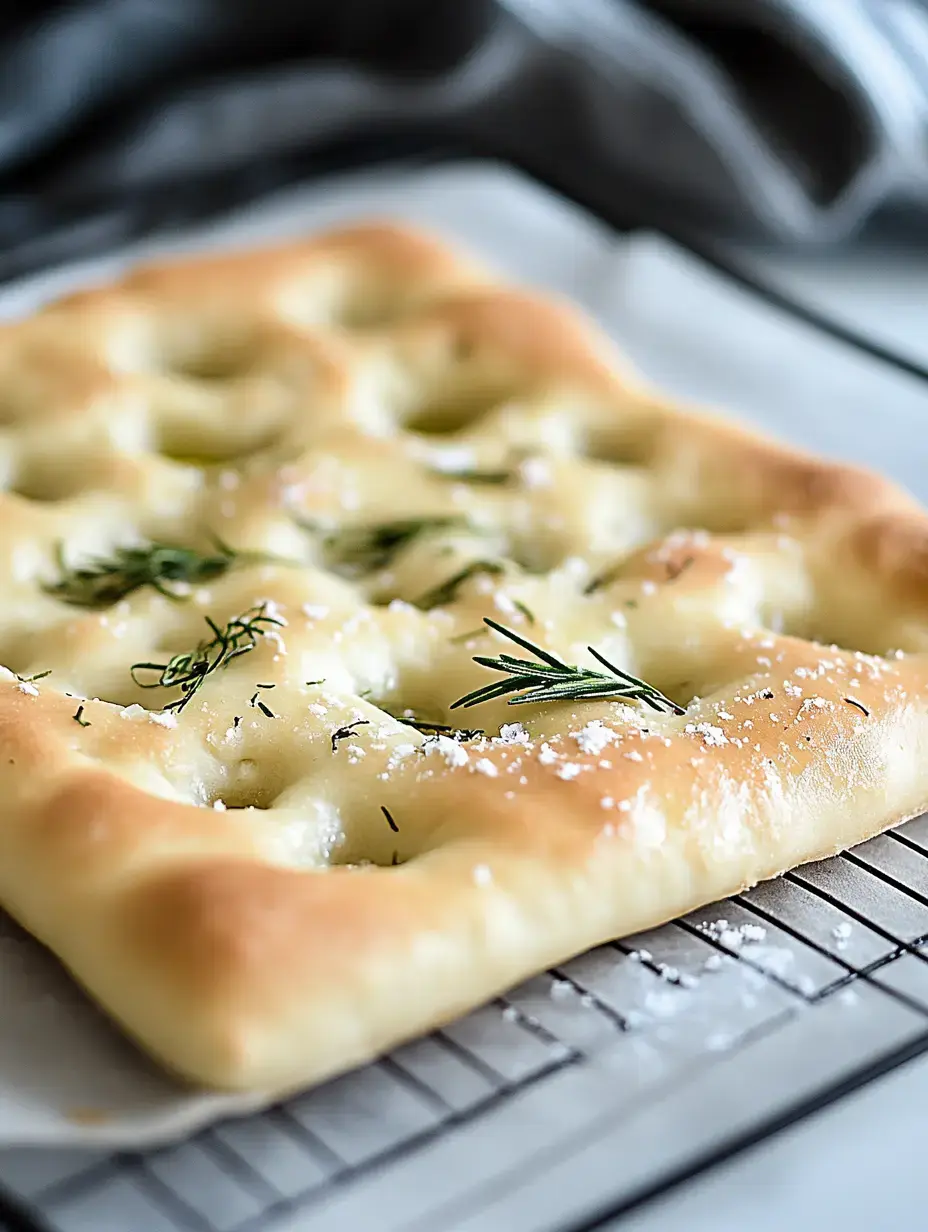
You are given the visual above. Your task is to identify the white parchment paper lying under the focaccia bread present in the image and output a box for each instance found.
[0,166,928,1145]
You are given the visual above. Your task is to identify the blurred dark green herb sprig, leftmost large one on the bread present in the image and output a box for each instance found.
[46,538,270,607]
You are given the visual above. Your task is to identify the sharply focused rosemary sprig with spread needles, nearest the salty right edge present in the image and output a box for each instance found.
[451,616,684,715]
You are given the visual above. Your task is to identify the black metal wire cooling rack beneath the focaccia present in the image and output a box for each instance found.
[0,211,928,1232]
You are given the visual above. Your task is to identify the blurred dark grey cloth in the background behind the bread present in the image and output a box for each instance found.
[0,0,928,278]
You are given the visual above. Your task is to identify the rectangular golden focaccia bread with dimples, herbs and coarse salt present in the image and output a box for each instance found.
[0,224,928,1092]
